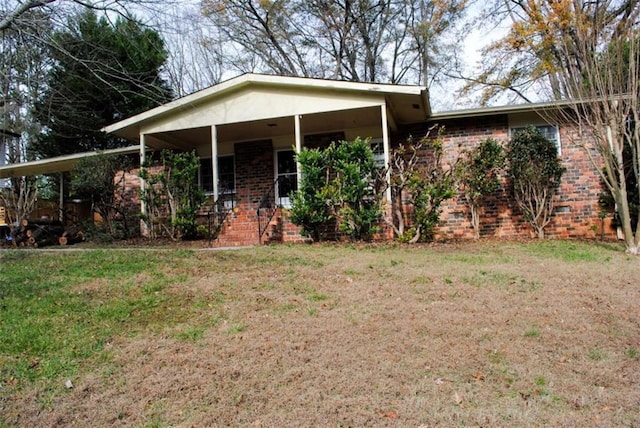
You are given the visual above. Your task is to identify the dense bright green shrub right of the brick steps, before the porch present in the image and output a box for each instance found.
[291,138,384,240]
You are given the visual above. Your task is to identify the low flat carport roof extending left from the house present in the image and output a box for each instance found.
[0,146,140,178]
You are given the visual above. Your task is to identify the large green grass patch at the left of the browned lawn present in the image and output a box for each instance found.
[0,251,196,382]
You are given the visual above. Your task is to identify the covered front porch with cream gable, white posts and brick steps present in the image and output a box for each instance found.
[104,75,429,245]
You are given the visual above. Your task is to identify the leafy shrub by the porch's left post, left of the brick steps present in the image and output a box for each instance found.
[140,150,205,239]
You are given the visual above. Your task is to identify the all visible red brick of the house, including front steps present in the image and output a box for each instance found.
[119,115,615,246]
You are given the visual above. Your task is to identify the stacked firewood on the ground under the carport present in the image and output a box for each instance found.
[14,219,84,248]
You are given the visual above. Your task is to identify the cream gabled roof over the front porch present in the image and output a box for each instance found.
[103,74,431,141]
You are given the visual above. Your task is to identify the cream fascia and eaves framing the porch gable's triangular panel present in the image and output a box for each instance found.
[103,74,431,141]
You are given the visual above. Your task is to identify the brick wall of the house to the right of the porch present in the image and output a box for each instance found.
[397,115,615,239]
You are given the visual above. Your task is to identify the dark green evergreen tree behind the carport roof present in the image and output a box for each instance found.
[33,10,171,157]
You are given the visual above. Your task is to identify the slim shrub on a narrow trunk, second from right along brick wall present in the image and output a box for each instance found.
[456,138,505,239]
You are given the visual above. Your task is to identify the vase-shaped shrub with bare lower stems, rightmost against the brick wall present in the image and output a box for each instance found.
[507,126,565,239]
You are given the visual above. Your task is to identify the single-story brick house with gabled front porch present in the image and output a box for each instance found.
[0,74,612,246]
